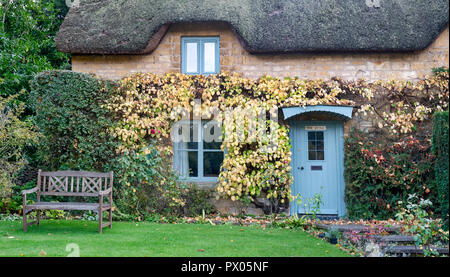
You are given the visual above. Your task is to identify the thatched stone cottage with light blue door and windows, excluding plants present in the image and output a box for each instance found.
[56,0,449,216]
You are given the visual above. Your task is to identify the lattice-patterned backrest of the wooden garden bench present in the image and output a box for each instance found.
[38,170,113,196]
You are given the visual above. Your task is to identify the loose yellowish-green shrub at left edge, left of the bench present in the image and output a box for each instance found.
[0,97,37,212]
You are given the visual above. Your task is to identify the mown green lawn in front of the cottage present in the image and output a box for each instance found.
[0,220,349,257]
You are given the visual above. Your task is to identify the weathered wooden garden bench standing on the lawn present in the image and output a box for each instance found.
[22,170,113,234]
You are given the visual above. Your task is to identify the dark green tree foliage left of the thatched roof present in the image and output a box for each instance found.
[0,0,69,101]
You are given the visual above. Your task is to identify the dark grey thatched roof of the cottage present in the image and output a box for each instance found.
[56,0,449,54]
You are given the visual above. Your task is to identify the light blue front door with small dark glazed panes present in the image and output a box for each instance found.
[290,121,345,216]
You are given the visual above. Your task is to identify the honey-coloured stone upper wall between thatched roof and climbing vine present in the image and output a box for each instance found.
[72,23,449,81]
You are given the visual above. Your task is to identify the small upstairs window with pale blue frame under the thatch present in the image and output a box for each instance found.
[181,37,220,75]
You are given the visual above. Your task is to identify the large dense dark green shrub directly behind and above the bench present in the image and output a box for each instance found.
[30,71,118,171]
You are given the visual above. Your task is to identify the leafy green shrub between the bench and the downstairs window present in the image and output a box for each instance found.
[111,147,214,220]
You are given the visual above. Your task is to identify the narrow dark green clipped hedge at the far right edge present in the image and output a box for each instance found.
[432,111,449,230]
